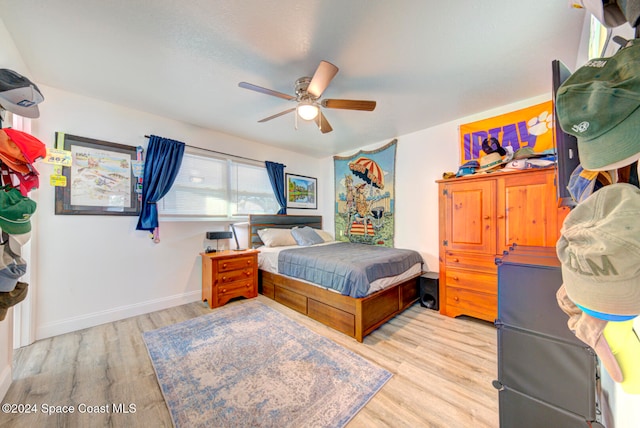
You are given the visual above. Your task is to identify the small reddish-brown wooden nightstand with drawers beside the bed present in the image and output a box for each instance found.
[200,250,259,309]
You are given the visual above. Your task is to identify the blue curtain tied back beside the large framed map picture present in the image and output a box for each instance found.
[136,135,184,242]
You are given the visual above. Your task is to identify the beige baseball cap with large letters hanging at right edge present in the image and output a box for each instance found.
[556,183,640,315]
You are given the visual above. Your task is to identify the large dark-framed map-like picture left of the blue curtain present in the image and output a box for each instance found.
[55,133,140,216]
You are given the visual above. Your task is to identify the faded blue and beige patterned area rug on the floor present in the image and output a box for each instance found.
[143,300,392,428]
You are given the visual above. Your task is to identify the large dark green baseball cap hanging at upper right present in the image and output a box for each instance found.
[556,39,640,171]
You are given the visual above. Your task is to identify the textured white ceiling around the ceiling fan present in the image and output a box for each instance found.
[0,0,584,157]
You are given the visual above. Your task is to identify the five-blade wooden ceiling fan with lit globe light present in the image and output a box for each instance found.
[238,61,376,134]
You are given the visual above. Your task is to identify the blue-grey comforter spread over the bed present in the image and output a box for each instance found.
[278,242,422,297]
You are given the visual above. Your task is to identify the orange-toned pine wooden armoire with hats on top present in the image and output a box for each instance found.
[438,167,569,322]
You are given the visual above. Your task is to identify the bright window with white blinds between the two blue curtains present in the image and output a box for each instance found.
[158,150,280,218]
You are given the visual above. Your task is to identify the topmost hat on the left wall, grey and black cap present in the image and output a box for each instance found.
[0,68,44,119]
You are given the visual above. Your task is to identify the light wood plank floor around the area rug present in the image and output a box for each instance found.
[0,295,499,428]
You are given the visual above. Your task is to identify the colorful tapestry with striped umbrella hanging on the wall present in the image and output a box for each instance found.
[333,139,397,247]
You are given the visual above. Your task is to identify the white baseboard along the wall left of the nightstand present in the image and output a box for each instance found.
[36,290,202,340]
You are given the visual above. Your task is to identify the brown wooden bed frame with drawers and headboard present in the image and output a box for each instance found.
[249,214,420,342]
